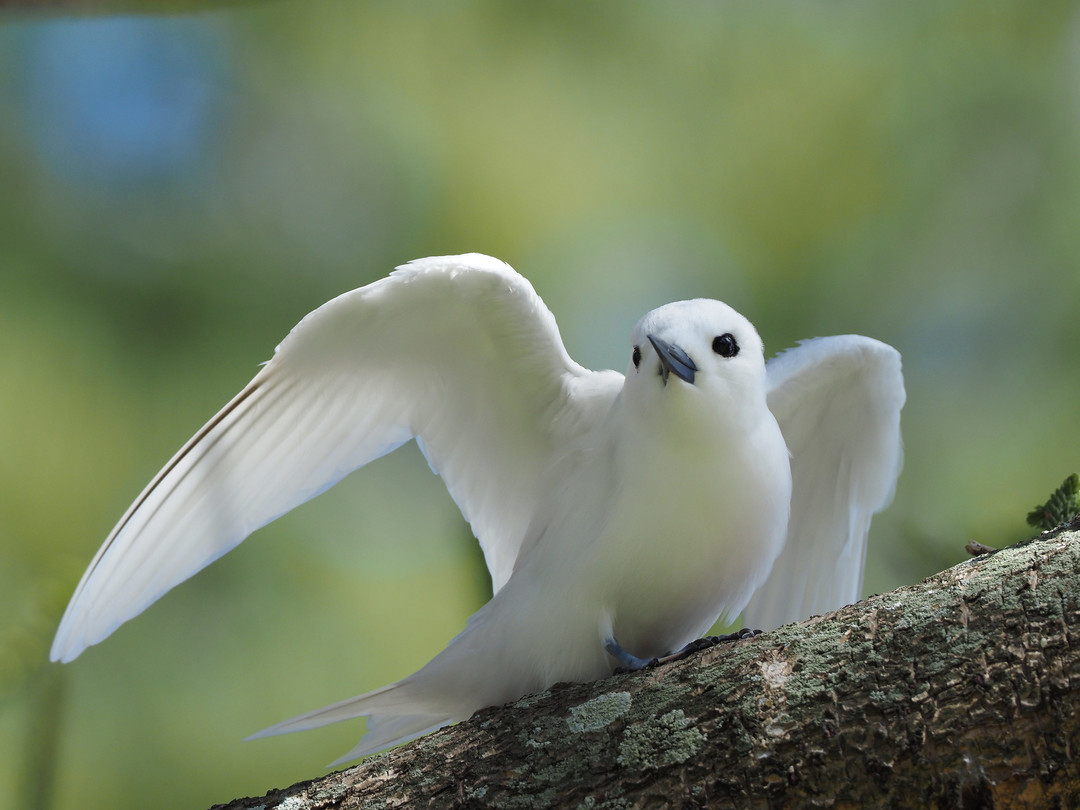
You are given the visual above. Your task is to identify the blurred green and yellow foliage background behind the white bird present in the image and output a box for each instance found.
[0,0,1080,808]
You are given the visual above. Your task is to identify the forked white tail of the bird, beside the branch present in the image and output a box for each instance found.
[246,678,460,767]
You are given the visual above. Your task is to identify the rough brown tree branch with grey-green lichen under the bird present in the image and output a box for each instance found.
[212,525,1080,810]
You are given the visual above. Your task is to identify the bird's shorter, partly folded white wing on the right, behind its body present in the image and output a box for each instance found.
[743,335,905,630]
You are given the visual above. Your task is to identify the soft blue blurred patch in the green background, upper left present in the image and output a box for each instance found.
[15,17,229,188]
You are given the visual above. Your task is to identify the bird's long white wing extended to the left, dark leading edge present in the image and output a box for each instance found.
[51,254,613,661]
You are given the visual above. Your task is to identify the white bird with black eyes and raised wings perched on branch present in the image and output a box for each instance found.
[51,254,904,765]
